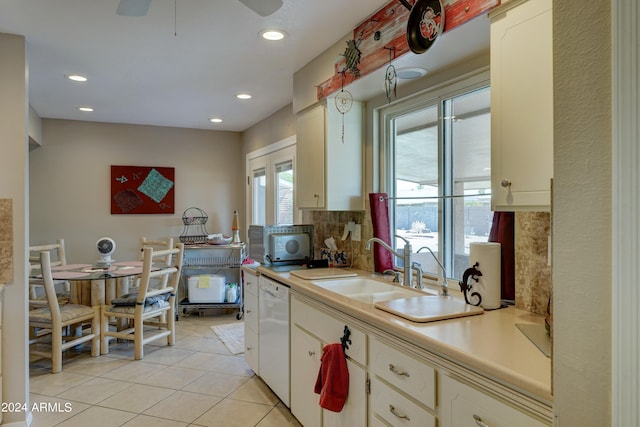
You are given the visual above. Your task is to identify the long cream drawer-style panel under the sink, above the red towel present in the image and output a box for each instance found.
[291,296,367,365]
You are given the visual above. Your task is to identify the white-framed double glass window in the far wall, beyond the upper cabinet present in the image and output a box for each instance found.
[247,139,300,225]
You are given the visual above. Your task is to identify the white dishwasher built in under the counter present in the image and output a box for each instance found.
[258,276,290,407]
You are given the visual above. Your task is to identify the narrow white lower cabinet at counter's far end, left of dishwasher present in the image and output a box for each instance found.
[242,268,260,375]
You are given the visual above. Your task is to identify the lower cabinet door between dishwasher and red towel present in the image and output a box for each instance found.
[291,325,322,427]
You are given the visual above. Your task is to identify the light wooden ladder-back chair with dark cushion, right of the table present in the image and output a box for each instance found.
[100,243,184,360]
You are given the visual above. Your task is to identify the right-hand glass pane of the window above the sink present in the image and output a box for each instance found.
[444,88,492,279]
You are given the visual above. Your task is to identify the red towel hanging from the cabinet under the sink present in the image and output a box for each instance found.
[313,344,349,412]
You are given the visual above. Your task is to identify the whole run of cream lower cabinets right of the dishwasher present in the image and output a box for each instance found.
[282,293,552,427]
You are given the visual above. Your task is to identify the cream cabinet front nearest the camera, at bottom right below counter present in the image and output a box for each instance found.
[438,374,551,427]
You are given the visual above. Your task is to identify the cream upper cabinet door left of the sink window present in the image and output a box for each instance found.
[295,104,325,209]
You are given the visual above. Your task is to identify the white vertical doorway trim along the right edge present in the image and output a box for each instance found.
[611,0,640,426]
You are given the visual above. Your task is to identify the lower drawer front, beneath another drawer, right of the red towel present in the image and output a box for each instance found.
[371,378,436,427]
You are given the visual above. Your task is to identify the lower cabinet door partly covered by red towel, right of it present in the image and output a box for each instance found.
[322,359,367,427]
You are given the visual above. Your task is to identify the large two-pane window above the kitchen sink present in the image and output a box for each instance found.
[382,75,492,279]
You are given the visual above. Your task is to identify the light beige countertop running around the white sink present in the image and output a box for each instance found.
[256,266,553,405]
